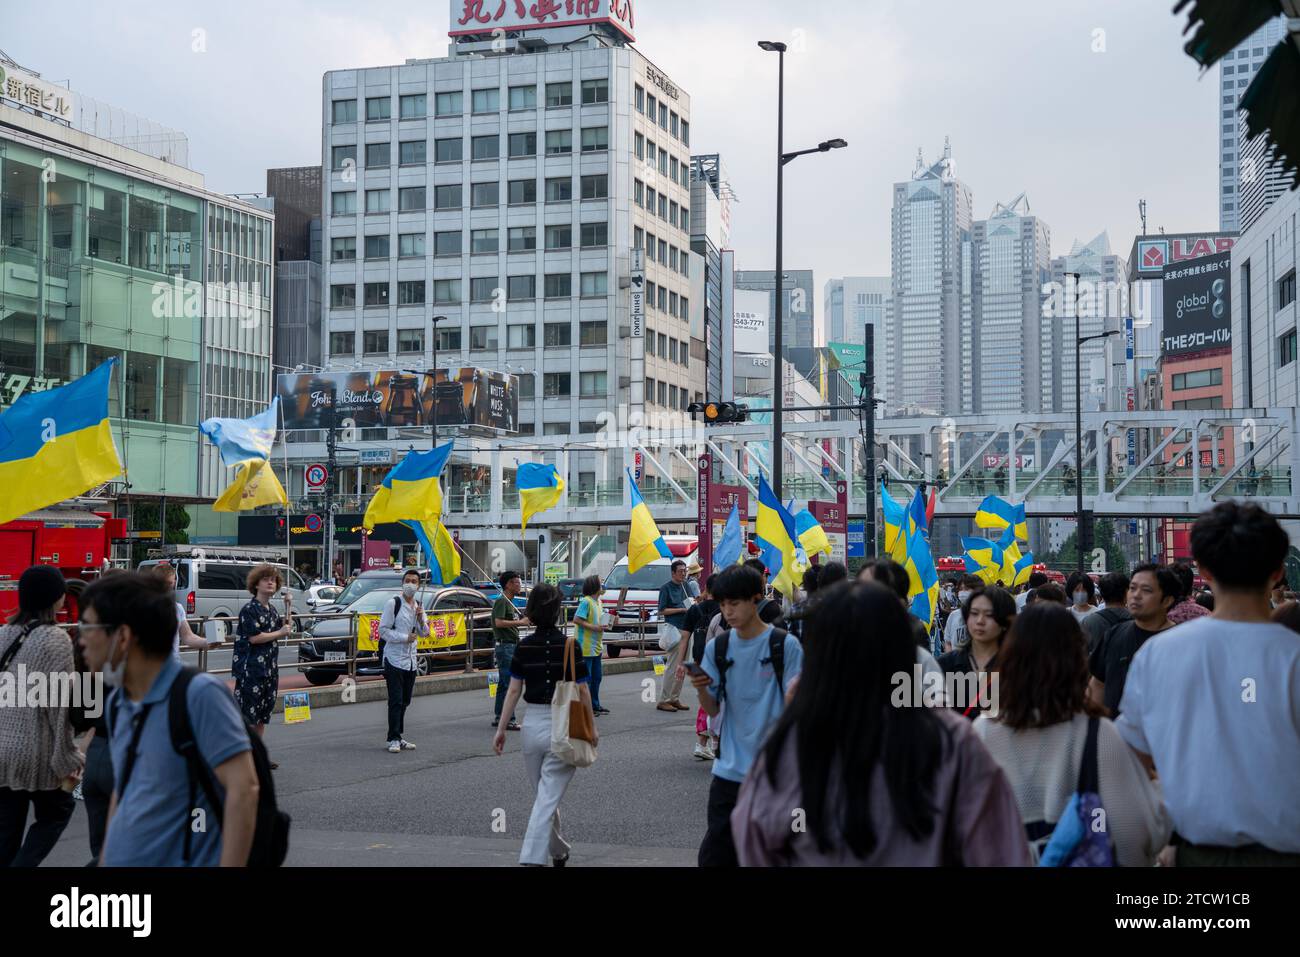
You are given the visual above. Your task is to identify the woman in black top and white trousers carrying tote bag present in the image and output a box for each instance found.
[493,583,599,867]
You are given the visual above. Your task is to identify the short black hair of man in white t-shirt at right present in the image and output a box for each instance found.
[1192,502,1291,589]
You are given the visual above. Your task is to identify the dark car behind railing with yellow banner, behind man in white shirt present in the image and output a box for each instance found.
[298,588,493,685]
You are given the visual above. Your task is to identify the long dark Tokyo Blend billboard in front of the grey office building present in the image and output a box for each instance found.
[276,367,519,432]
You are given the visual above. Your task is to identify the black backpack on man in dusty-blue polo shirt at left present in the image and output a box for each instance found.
[112,668,290,867]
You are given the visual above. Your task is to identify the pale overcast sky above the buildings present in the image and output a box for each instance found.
[0,0,1218,283]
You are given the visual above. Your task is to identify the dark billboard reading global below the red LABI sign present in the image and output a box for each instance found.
[1161,252,1232,355]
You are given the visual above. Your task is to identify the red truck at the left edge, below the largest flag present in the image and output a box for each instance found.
[0,508,126,620]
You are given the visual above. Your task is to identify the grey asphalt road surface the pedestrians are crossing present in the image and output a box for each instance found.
[46,672,710,867]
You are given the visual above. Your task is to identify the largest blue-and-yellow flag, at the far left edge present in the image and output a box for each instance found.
[0,358,122,524]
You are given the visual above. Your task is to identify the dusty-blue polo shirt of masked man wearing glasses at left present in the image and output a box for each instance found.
[100,658,252,867]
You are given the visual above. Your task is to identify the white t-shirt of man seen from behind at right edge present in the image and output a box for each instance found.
[1115,616,1300,854]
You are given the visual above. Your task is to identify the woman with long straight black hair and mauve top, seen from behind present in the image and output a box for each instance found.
[719,583,1030,866]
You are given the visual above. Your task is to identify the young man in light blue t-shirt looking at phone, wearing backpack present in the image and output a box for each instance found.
[690,566,803,867]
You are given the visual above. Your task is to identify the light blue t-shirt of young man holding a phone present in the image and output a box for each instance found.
[701,627,803,783]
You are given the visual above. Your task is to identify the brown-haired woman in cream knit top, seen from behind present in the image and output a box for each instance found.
[974,602,1170,867]
